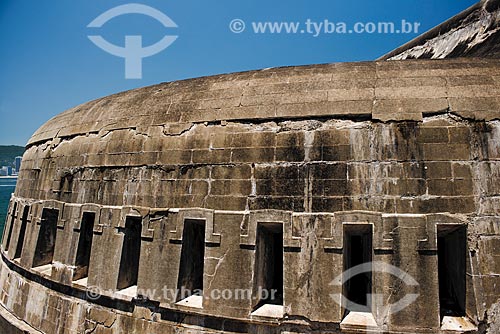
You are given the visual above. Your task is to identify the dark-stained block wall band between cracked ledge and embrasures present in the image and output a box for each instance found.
[12,114,500,214]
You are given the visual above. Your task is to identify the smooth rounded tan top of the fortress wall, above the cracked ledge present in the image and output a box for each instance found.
[27,58,500,147]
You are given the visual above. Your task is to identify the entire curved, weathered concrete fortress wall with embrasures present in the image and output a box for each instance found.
[0,59,500,334]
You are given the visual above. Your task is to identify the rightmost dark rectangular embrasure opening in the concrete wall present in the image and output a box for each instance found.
[437,225,467,317]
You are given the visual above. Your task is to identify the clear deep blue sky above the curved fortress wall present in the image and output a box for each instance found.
[0,0,476,145]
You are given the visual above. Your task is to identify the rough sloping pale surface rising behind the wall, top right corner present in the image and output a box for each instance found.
[380,0,500,60]
